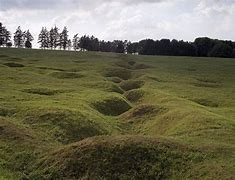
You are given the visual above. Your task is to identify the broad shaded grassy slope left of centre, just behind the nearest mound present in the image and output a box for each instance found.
[23,108,106,143]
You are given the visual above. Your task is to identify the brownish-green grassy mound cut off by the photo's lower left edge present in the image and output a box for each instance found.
[0,117,47,179]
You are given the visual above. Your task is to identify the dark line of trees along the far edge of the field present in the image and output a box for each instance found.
[0,23,235,58]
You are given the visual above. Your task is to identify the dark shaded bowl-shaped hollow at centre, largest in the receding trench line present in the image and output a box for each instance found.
[92,96,131,116]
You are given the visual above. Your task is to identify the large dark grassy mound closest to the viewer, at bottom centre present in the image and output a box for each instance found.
[30,136,202,179]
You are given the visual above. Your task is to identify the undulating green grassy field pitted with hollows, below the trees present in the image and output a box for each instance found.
[0,48,235,179]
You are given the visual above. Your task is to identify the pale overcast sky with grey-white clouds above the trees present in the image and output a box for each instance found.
[0,0,235,47]
